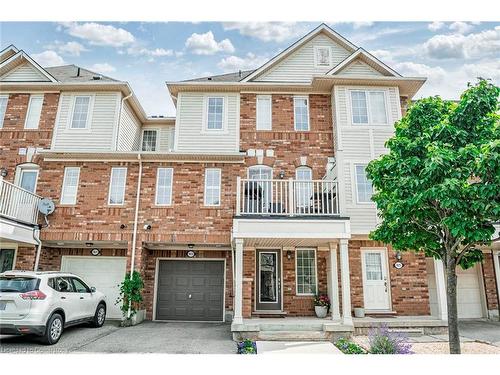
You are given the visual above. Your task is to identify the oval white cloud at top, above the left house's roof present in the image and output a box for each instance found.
[62,22,135,47]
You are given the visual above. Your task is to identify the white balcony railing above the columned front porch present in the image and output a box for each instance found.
[236,177,339,216]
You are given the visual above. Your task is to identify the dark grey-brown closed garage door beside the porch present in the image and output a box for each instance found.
[155,260,224,321]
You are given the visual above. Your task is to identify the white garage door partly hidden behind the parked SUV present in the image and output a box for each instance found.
[61,256,127,319]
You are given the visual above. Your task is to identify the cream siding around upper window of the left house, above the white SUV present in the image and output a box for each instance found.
[52,92,121,151]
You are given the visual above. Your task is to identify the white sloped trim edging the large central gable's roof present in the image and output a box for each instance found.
[241,23,358,82]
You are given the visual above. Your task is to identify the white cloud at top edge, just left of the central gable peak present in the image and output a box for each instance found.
[222,22,307,43]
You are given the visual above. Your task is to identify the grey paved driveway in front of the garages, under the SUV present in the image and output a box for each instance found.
[0,321,236,354]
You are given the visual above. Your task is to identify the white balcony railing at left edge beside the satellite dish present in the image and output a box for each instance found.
[0,179,42,224]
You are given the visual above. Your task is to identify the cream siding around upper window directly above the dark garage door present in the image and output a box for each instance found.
[175,93,240,153]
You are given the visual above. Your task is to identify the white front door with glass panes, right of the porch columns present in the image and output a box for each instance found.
[361,249,391,310]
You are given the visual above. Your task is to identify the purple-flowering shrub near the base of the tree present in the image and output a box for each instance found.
[368,324,413,354]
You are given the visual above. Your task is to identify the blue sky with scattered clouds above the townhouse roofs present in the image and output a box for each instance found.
[0,21,500,116]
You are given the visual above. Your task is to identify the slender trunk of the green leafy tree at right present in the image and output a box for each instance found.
[446,259,461,354]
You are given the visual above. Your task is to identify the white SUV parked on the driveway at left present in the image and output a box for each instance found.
[0,271,106,345]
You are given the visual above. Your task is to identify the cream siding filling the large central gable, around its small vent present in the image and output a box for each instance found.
[254,34,350,82]
